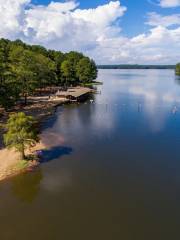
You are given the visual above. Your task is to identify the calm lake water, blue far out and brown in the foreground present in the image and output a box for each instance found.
[0,70,180,240]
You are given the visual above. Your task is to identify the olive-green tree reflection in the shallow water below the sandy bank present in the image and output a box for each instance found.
[12,168,43,203]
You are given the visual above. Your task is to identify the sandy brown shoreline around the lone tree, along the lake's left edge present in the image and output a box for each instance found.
[0,99,68,182]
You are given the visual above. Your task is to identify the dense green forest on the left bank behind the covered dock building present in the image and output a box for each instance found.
[0,39,97,108]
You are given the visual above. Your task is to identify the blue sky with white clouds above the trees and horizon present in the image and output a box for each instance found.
[0,0,180,64]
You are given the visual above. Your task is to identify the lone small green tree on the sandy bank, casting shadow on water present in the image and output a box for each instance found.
[4,112,39,159]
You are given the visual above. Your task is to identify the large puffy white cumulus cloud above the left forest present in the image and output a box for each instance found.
[24,1,125,51]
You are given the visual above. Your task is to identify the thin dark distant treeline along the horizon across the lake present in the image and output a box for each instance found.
[97,64,176,69]
